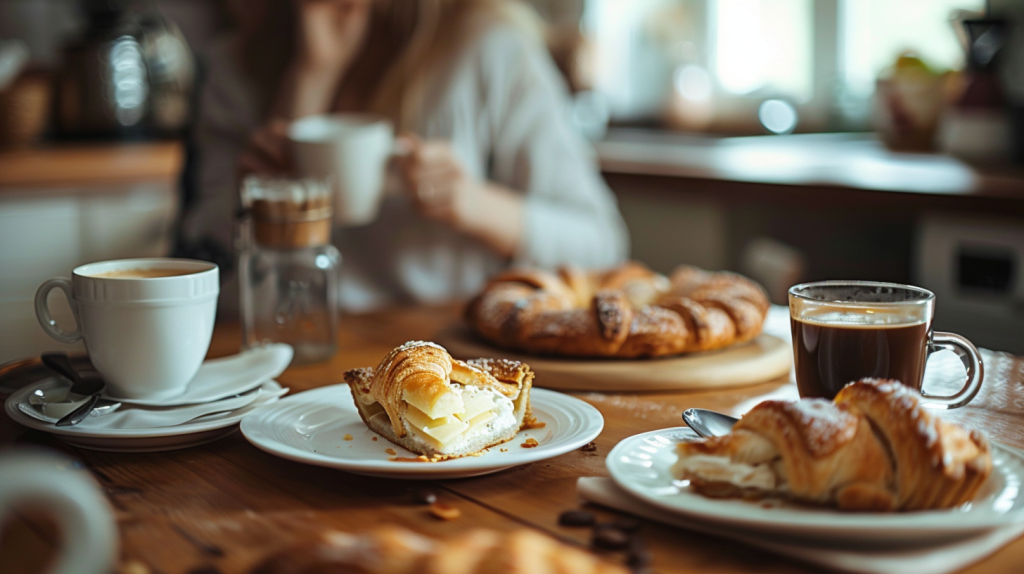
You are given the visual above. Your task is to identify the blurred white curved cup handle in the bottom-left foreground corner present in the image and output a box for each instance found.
[0,450,118,574]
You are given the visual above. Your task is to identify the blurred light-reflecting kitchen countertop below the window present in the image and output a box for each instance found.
[596,129,1024,208]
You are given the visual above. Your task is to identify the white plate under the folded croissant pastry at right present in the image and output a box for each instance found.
[605,428,1024,545]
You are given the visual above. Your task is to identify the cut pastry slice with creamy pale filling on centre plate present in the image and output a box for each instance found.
[344,341,534,460]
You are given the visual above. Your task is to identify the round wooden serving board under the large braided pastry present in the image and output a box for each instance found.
[434,324,793,392]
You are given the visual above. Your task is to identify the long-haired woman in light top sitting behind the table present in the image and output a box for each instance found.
[183,0,628,309]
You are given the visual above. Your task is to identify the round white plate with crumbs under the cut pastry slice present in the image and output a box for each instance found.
[242,385,604,479]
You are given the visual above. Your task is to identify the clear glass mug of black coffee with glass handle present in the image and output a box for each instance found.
[790,281,984,408]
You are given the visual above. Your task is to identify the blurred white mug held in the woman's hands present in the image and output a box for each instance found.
[288,114,394,225]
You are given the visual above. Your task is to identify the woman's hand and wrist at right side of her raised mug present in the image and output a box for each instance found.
[398,134,522,257]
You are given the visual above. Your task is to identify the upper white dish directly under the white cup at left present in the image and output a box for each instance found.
[103,343,294,406]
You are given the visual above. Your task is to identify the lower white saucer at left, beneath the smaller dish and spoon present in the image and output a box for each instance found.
[4,380,282,452]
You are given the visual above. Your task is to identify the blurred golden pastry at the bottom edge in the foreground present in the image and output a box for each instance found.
[252,526,628,574]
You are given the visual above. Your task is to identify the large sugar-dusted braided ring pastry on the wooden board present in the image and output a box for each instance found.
[466,262,770,358]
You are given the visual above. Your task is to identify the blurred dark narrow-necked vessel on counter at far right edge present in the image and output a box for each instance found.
[939,19,1011,161]
